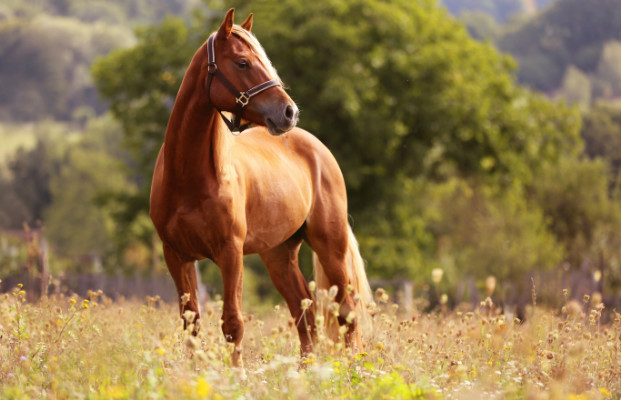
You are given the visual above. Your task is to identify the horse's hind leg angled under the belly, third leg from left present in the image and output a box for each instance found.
[259,235,315,357]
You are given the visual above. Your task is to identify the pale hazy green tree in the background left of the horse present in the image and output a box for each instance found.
[45,118,131,257]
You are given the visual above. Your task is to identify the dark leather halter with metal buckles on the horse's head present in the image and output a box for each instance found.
[205,32,281,133]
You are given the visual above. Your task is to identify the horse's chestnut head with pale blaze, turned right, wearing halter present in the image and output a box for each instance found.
[203,9,299,135]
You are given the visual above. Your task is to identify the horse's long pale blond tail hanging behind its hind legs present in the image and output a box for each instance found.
[313,226,373,344]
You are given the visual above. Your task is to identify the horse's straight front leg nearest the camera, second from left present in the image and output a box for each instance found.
[215,245,244,368]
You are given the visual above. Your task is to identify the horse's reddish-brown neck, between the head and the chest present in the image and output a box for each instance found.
[164,71,231,187]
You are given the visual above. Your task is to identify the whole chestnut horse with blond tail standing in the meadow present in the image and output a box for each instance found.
[149,9,371,367]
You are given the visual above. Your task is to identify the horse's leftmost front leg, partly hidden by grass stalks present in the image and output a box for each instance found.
[163,243,200,335]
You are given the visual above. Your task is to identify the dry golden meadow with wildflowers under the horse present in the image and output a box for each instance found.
[0,287,621,399]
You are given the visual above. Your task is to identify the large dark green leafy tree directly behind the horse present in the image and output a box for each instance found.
[93,0,581,294]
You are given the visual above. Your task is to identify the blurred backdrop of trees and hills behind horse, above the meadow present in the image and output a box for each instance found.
[0,0,621,311]
